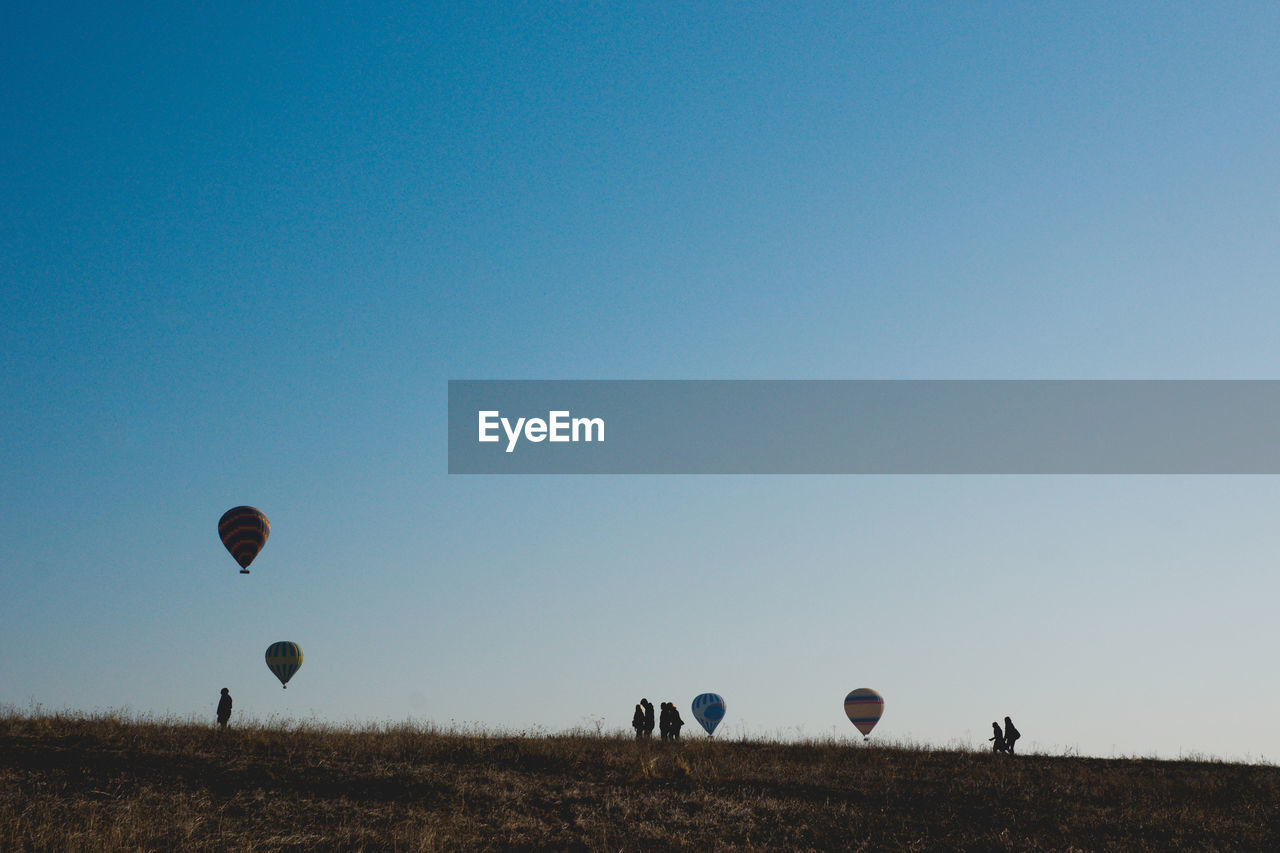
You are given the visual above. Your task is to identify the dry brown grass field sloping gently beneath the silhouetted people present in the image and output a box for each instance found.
[0,711,1280,850]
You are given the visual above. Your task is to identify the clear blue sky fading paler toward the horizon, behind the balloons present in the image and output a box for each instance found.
[0,3,1280,761]
